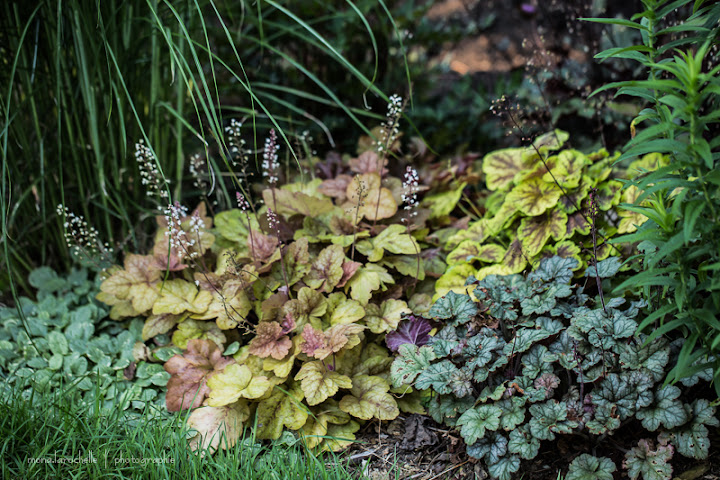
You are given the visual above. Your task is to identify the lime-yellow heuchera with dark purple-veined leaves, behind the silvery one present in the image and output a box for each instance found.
[436,130,663,295]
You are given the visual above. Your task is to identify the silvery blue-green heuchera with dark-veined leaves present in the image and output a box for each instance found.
[391,257,720,480]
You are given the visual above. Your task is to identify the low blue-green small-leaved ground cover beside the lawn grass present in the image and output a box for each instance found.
[0,267,169,412]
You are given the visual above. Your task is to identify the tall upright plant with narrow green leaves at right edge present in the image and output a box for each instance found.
[593,1,720,394]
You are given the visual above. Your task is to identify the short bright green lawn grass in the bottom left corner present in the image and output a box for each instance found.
[0,378,360,480]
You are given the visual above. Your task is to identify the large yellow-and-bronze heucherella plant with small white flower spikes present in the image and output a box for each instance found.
[98,124,456,450]
